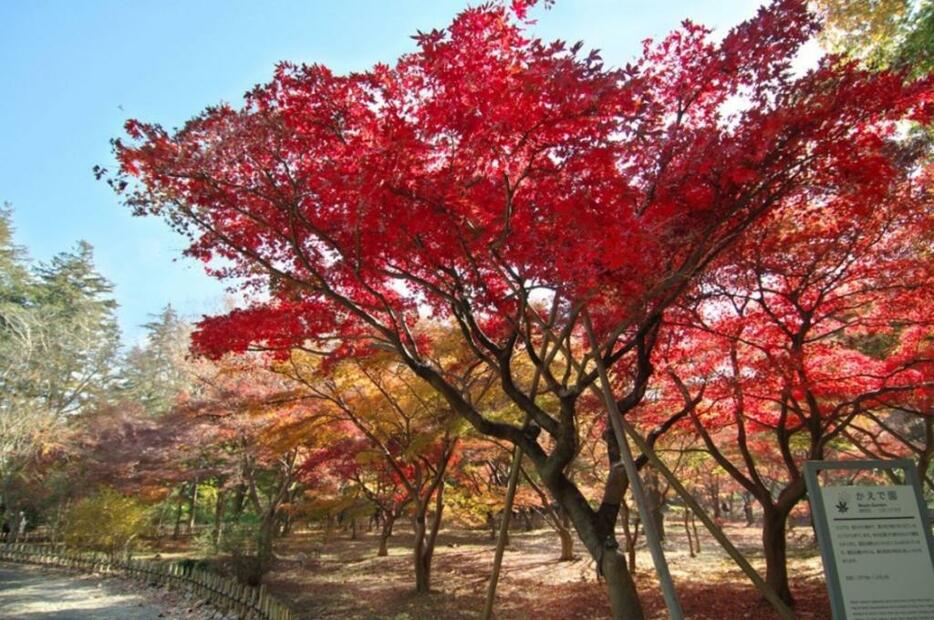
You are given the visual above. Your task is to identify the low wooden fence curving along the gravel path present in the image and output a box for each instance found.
[0,543,295,620]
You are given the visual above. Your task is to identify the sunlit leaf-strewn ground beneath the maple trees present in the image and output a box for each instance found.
[266,523,831,620]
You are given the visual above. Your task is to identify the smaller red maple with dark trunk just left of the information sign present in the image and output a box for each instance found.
[663,159,934,602]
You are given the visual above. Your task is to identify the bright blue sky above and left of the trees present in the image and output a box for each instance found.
[0,0,758,343]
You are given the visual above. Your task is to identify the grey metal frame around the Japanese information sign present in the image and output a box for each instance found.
[804,459,934,620]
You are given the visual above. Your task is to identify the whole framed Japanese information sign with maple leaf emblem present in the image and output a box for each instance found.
[804,459,934,620]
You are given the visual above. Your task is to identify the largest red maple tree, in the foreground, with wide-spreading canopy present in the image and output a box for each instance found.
[111,0,930,618]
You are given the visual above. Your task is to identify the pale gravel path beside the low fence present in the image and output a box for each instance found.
[0,564,219,620]
